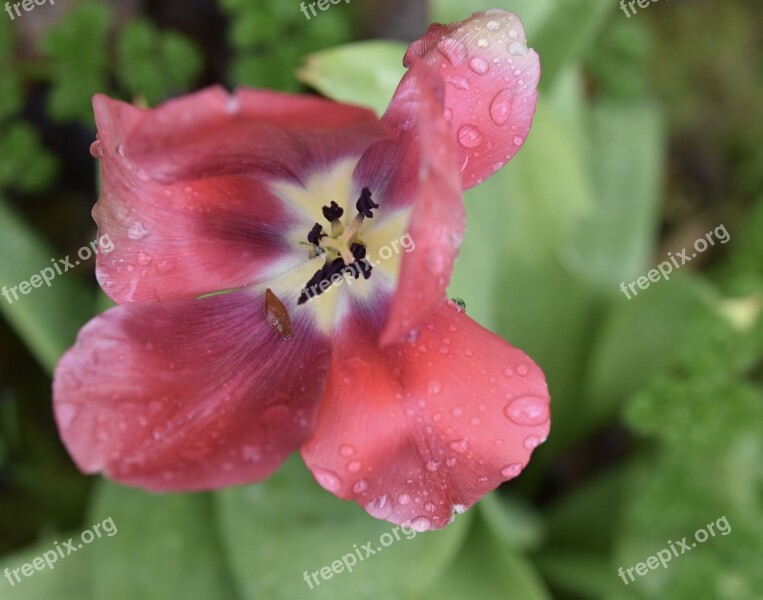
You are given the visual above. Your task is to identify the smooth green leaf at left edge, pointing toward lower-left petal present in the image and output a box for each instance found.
[0,198,92,373]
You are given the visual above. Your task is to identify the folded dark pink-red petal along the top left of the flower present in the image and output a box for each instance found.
[119,87,389,182]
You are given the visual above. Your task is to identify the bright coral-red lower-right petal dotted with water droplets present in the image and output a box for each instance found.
[302,303,550,529]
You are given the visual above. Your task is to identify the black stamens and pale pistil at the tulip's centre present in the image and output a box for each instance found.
[298,188,379,304]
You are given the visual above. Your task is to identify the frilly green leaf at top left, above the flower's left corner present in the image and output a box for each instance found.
[41,3,112,125]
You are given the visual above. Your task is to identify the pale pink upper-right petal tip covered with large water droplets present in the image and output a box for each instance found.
[402,9,540,189]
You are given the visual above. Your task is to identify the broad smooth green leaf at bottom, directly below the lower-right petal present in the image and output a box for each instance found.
[217,456,470,600]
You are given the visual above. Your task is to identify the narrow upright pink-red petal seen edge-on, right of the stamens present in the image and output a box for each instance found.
[355,61,466,344]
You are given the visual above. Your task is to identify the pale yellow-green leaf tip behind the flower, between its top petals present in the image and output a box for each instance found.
[297,41,407,115]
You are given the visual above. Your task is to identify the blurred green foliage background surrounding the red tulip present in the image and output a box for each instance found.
[0,0,763,600]
